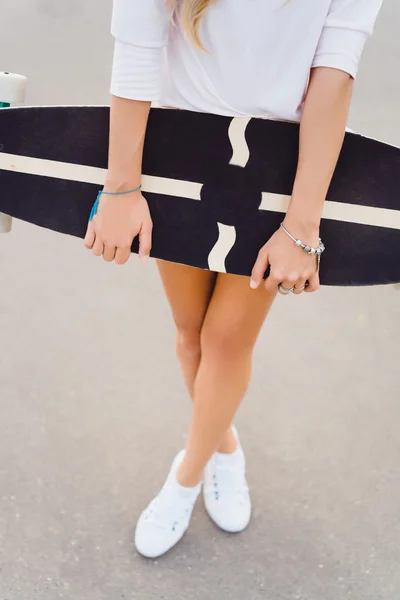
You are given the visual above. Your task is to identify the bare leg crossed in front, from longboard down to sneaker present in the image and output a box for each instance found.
[177,274,276,487]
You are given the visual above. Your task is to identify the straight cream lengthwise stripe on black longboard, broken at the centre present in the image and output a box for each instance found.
[0,152,400,230]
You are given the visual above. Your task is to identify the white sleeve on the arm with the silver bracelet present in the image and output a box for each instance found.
[312,0,383,78]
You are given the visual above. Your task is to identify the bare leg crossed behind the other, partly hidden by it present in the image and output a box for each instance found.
[157,260,237,452]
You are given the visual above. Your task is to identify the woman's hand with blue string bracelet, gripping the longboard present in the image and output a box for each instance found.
[84,186,153,265]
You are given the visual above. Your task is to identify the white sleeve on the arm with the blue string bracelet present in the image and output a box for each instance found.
[111,0,170,102]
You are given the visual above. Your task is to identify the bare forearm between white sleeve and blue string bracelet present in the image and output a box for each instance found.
[106,96,151,191]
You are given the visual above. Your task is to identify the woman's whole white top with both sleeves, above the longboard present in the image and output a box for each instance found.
[111,0,382,121]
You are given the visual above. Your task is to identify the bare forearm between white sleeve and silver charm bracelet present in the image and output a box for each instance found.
[285,67,353,236]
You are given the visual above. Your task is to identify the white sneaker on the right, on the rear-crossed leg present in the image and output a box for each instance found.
[204,429,251,533]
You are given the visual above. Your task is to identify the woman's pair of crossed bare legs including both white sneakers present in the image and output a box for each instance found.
[135,265,275,558]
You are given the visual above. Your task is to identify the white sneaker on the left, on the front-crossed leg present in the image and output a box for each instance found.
[135,450,201,558]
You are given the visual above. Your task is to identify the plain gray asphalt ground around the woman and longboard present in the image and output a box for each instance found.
[0,0,400,600]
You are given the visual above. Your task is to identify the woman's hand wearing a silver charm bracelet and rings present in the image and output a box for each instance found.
[250,220,319,294]
